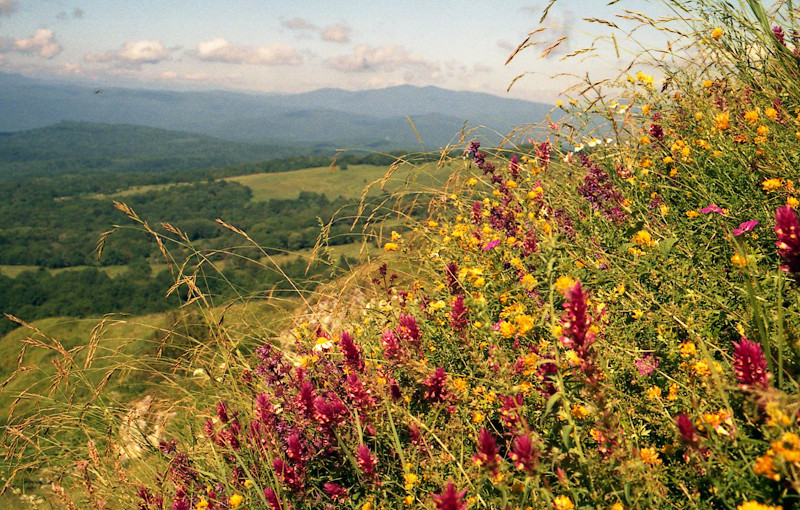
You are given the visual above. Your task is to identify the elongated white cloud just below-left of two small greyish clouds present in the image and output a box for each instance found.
[194,37,302,65]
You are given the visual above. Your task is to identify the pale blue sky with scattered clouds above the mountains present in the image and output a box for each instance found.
[0,0,654,101]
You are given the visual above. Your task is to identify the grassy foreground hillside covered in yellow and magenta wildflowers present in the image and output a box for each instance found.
[5,1,800,510]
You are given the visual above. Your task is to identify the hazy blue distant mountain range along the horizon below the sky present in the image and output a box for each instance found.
[0,73,551,150]
